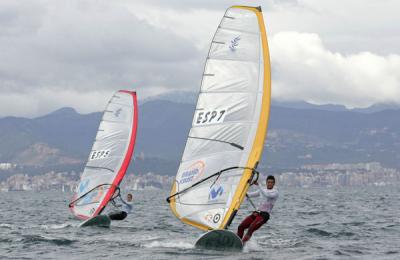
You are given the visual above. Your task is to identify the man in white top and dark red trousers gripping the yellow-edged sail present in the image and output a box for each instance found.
[237,175,279,243]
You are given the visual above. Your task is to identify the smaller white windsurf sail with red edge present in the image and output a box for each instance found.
[69,90,138,219]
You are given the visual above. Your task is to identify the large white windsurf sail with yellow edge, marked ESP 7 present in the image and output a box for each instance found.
[167,6,271,230]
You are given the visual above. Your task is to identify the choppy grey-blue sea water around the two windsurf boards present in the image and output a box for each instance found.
[0,187,400,259]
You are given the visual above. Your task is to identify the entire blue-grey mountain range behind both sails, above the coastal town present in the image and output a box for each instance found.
[0,100,400,180]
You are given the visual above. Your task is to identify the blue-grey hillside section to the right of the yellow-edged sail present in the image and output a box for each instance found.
[264,106,400,168]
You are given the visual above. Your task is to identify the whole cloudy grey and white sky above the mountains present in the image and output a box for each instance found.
[0,0,400,117]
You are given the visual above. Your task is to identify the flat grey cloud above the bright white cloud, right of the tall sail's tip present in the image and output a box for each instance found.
[264,0,400,55]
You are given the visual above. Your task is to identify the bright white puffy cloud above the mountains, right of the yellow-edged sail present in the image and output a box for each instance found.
[270,32,400,108]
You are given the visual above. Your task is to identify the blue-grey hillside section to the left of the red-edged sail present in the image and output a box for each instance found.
[0,108,101,166]
